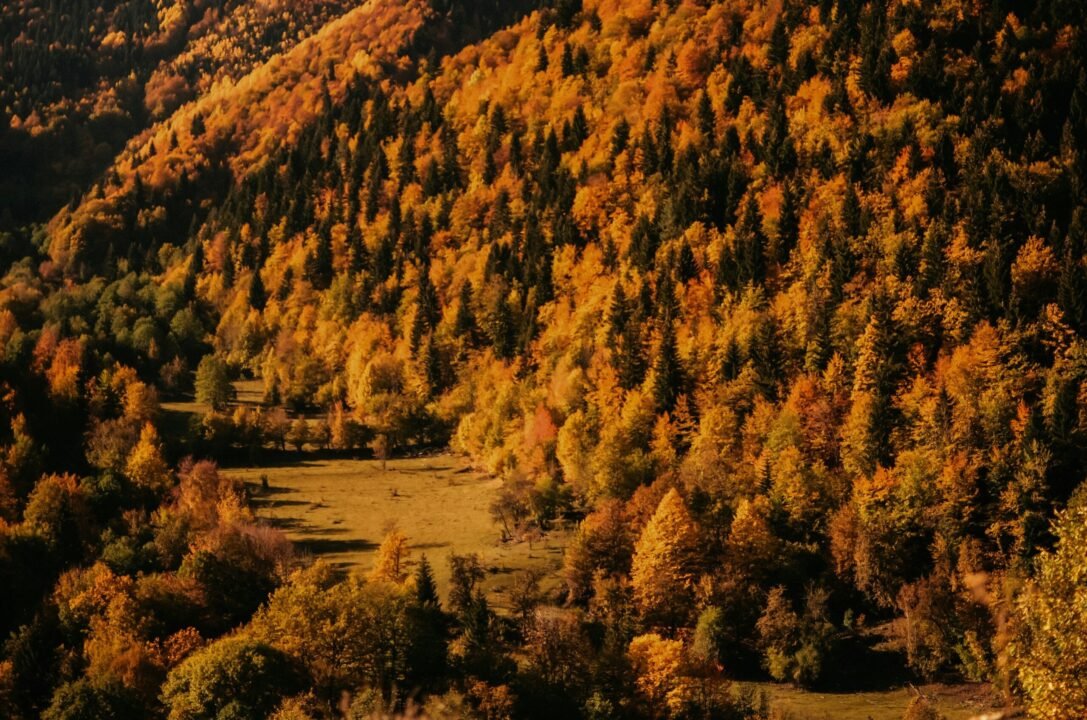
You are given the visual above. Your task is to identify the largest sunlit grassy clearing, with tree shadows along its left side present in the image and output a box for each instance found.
[227,455,566,609]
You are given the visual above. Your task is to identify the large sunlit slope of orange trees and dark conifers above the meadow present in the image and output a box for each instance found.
[0,0,1087,717]
